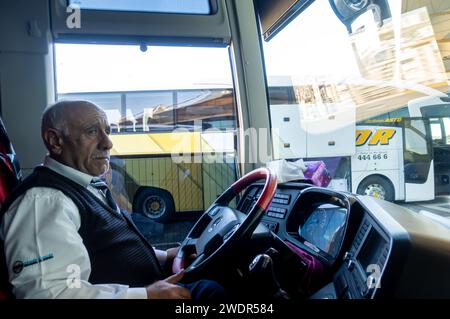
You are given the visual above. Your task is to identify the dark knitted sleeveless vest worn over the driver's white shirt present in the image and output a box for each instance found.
[2,166,163,287]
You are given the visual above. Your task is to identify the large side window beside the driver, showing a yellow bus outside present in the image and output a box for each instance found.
[55,44,237,244]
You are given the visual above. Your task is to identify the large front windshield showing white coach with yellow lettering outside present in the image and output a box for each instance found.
[263,0,450,201]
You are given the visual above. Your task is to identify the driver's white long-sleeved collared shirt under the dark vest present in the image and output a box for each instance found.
[0,156,166,298]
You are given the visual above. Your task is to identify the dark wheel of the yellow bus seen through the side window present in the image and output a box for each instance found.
[133,188,175,223]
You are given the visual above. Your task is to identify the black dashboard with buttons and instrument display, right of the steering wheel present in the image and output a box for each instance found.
[237,182,450,299]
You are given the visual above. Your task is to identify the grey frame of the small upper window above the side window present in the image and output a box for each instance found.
[50,0,231,46]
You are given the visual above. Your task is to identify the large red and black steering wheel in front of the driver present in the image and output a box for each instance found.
[172,168,277,279]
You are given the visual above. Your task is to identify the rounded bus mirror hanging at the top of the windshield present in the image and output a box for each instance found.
[329,0,391,34]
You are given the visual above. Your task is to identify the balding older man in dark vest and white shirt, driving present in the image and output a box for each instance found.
[0,101,223,299]
